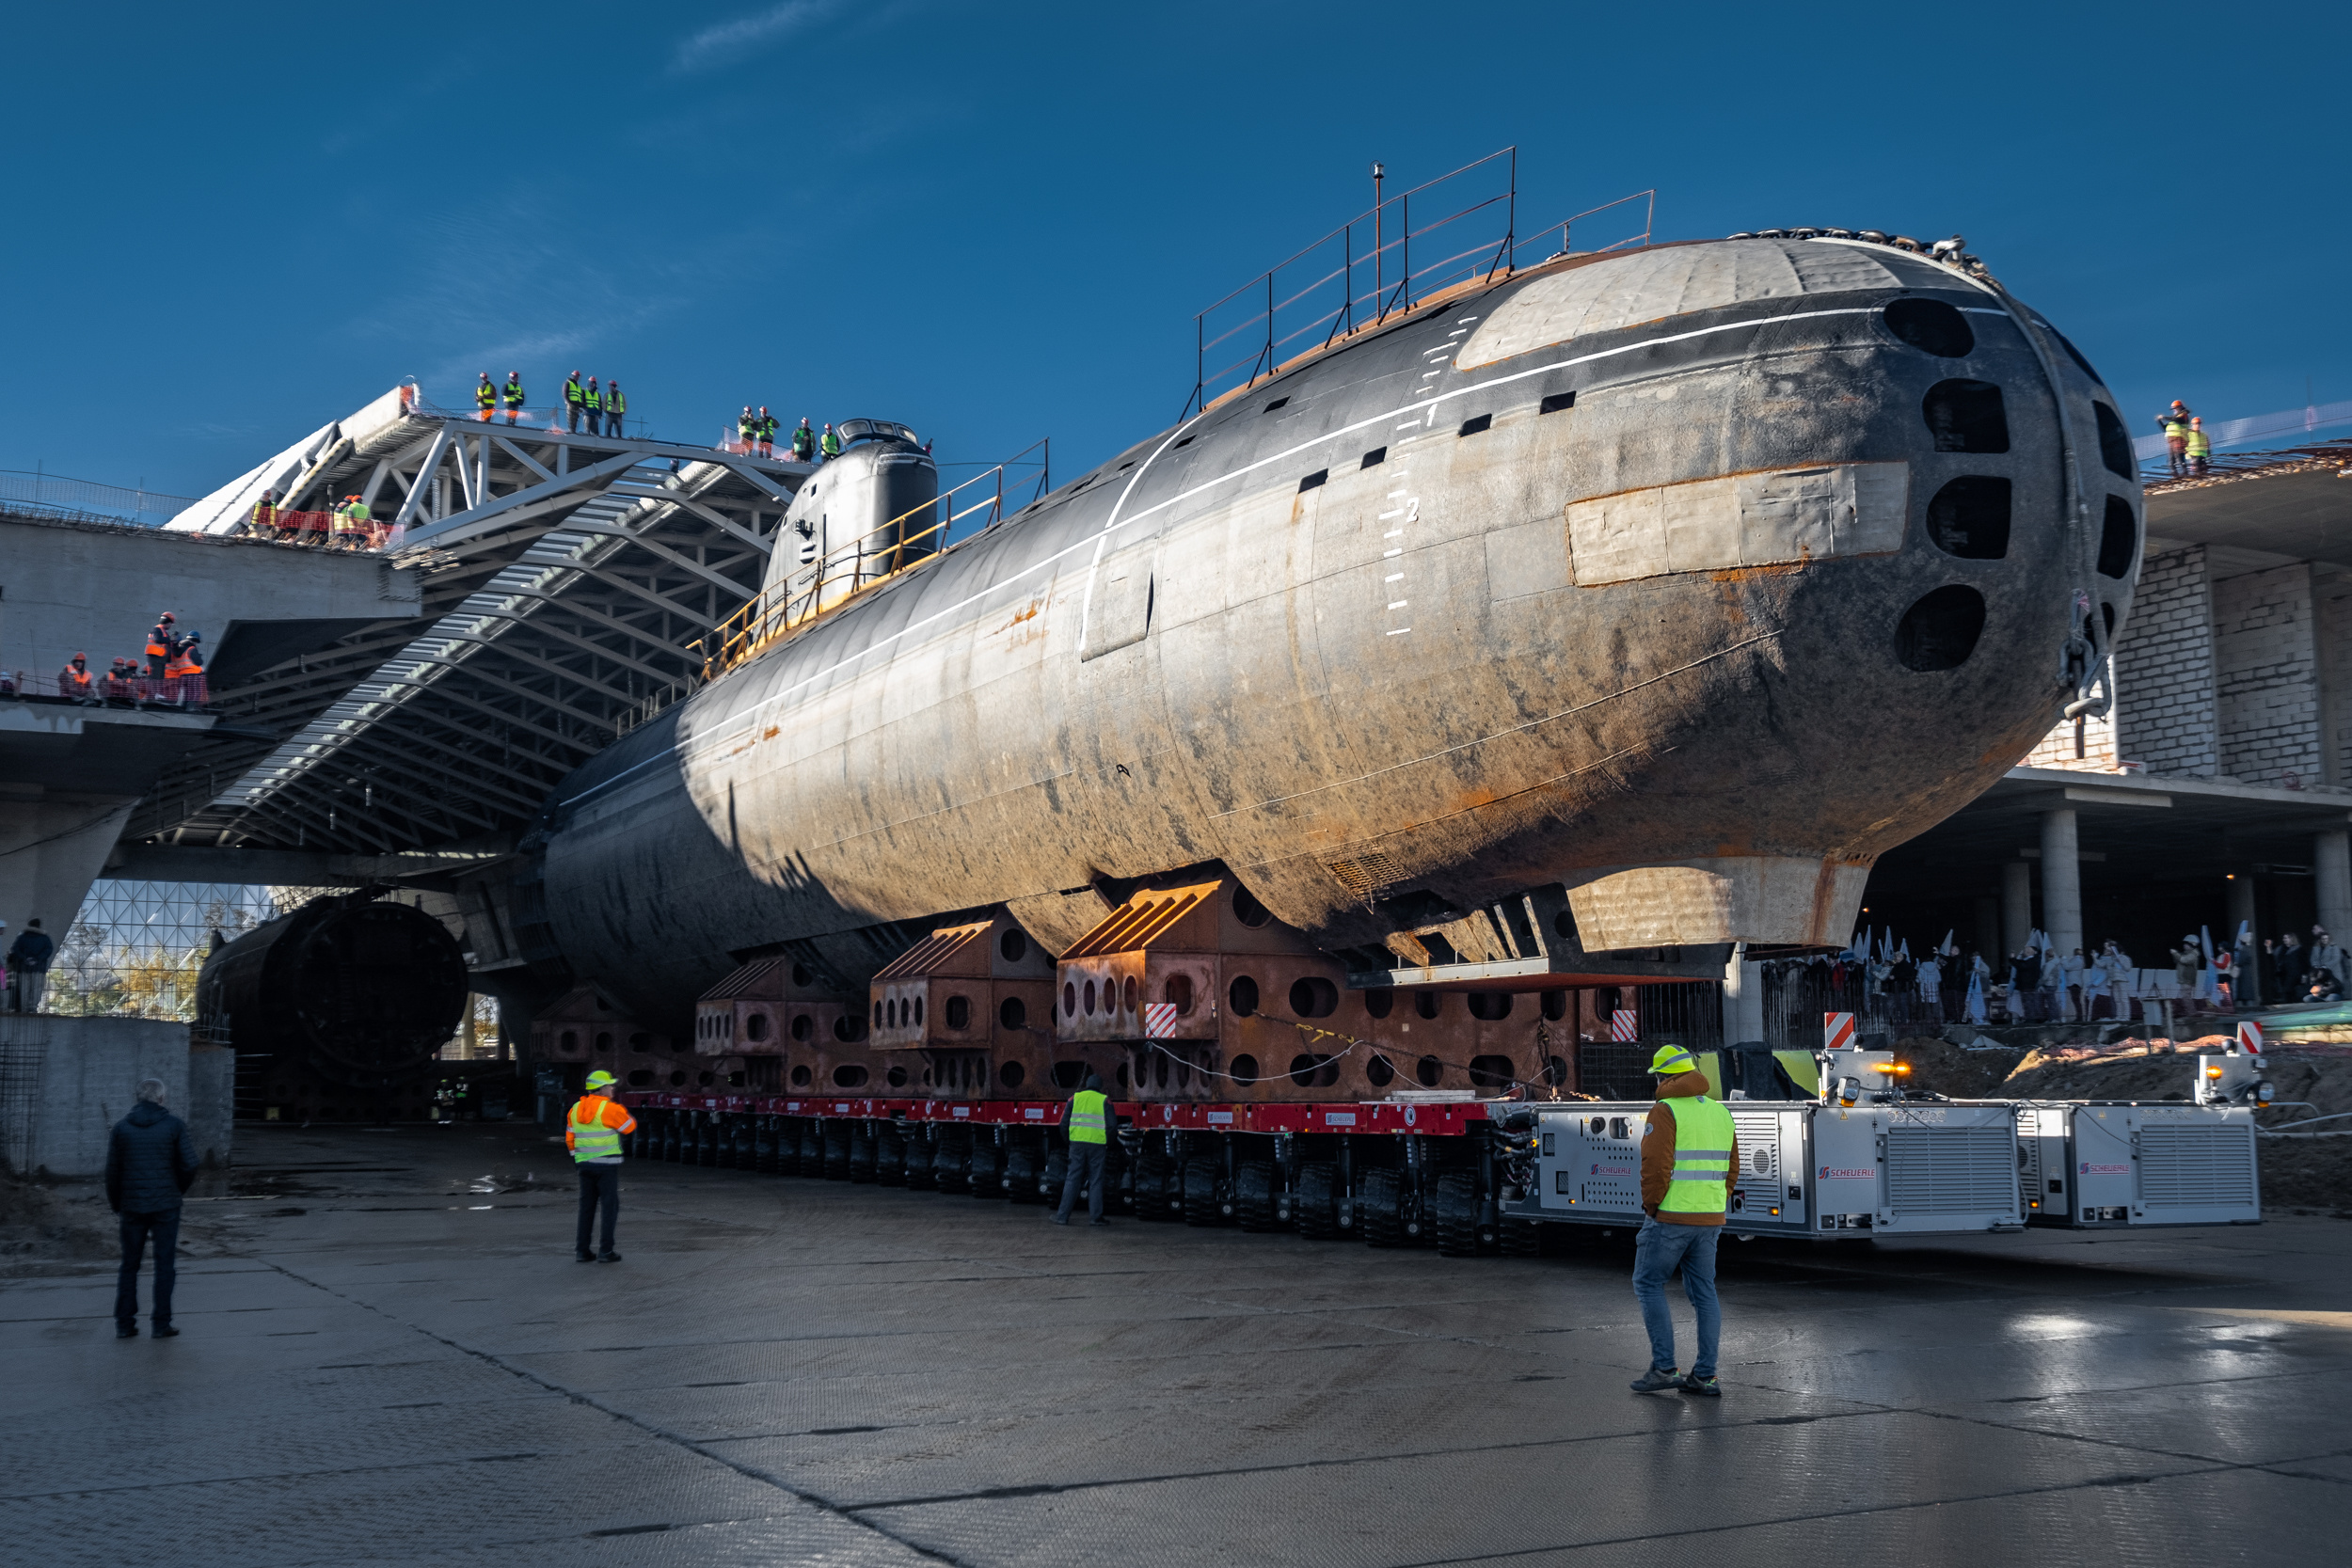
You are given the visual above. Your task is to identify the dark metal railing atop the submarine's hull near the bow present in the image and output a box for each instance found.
[1179,146,1659,419]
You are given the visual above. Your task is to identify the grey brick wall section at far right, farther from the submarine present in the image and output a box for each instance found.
[2211,562,2327,787]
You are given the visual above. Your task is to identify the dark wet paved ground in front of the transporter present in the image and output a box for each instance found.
[0,1126,2352,1568]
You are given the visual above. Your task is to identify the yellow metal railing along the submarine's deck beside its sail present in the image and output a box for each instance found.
[691,439,1052,679]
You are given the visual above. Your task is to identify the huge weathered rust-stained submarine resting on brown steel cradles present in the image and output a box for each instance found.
[541,227,2140,1018]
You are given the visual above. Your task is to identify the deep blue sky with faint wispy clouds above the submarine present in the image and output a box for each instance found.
[0,0,2352,494]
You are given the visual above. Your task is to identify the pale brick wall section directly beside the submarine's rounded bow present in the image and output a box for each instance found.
[2107,546,2220,778]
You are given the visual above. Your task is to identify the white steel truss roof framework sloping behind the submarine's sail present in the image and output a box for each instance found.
[125,409,812,853]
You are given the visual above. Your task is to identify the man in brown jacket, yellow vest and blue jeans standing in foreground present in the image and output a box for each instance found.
[1632,1046,1740,1397]
